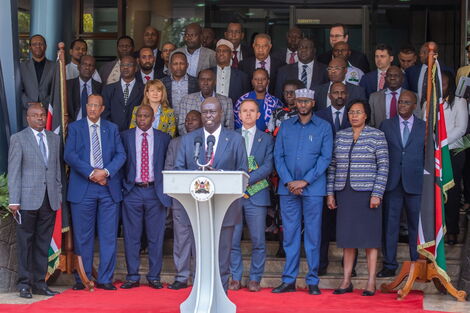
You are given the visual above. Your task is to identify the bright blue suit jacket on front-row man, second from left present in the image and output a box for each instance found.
[64,118,126,203]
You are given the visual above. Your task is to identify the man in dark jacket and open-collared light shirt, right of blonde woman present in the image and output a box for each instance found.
[162,51,199,107]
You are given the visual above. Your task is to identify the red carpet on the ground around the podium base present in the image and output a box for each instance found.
[0,286,444,313]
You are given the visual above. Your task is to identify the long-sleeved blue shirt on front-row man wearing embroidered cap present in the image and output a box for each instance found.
[274,115,333,196]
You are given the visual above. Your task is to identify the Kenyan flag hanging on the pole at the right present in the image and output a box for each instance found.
[418,61,454,281]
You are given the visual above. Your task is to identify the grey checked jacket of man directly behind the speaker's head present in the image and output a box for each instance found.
[173,91,234,135]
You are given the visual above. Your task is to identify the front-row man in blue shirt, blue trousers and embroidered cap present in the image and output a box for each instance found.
[272,88,333,295]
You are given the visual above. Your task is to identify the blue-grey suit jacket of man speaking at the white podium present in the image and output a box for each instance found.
[175,127,248,226]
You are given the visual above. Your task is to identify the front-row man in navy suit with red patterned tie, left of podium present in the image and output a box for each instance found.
[121,105,171,289]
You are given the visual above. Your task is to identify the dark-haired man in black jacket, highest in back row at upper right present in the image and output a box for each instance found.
[318,24,369,73]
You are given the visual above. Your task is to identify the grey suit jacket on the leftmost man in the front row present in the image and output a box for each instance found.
[8,127,62,211]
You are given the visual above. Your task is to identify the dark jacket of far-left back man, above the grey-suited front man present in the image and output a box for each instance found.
[20,59,56,122]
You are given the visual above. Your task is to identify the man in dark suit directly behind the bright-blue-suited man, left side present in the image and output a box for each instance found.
[67,55,102,123]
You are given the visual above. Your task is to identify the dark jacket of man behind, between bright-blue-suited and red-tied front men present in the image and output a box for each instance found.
[101,80,144,131]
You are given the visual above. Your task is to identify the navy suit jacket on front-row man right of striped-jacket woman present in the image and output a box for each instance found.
[380,115,426,194]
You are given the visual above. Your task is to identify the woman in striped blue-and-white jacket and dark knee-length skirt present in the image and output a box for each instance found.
[327,101,388,296]
